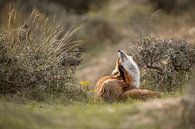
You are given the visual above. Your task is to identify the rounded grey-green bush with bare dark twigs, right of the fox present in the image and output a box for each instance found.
[131,36,193,92]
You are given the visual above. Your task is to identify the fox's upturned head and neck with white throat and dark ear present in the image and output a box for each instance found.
[112,50,140,87]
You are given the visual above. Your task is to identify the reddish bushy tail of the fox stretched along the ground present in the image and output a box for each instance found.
[121,88,161,99]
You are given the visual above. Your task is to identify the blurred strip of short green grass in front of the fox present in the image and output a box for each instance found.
[0,95,186,129]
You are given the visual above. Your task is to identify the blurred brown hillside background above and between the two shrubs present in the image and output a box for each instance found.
[0,0,195,85]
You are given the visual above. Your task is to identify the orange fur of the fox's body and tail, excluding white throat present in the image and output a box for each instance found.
[95,53,160,102]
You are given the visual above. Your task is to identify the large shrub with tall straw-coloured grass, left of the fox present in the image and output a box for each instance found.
[0,10,83,100]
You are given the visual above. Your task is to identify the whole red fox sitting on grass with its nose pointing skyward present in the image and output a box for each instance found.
[95,50,160,101]
